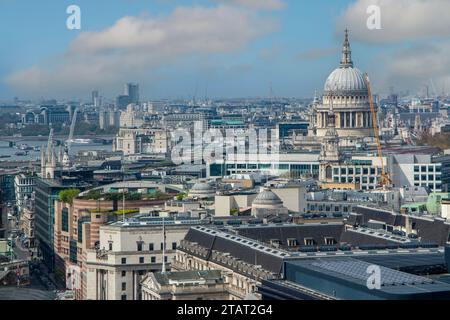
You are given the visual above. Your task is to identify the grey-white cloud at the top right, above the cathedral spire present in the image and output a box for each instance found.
[337,0,450,43]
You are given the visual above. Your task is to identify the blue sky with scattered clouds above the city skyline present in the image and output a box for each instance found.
[0,0,450,100]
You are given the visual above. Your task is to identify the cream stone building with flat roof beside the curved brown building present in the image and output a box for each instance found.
[86,218,207,300]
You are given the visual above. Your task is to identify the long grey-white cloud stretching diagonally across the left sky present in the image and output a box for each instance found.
[7,5,277,96]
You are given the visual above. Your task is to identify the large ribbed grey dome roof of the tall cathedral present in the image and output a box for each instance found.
[324,67,367,92]
